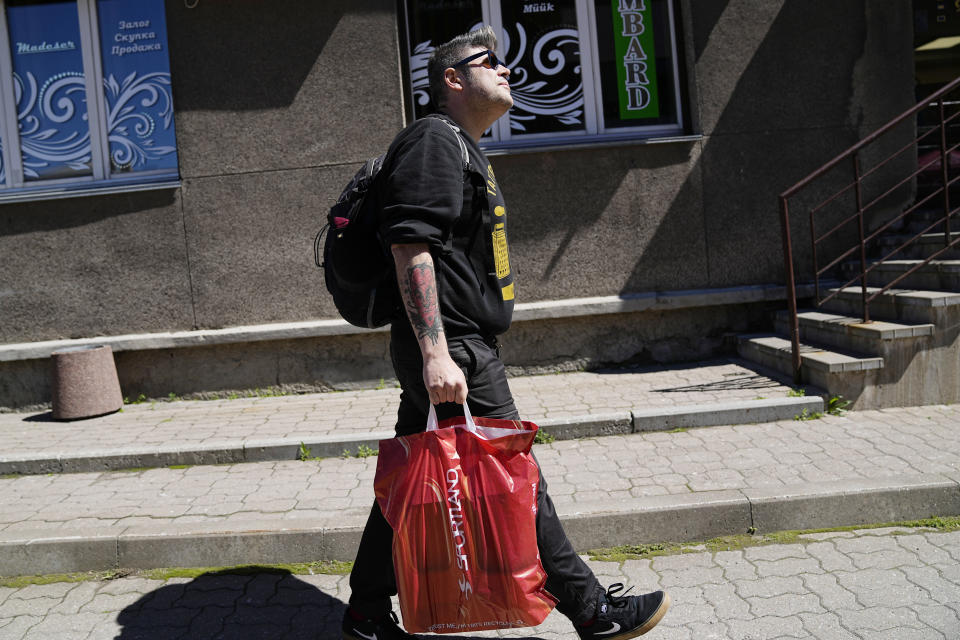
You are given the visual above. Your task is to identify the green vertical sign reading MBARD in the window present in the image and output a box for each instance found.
[611,0,660,120]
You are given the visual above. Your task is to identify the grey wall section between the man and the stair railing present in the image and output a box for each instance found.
[502,0,914,298]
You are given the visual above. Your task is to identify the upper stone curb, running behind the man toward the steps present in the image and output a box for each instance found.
[0,396,823,475]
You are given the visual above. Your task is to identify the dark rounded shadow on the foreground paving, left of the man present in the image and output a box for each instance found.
[115,567,537,640]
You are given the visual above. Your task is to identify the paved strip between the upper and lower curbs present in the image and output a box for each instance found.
[0,405,960,537]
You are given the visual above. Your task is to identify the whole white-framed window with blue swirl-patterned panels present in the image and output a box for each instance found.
[0,0,179,202]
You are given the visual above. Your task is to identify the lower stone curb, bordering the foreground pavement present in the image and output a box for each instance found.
[0,474,960,576]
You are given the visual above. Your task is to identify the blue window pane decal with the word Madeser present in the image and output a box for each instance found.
[7,2,92,181]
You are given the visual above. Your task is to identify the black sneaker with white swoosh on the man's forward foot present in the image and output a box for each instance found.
[577,582,670,640]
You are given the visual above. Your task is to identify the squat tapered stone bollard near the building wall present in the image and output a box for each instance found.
[51,345,123,420]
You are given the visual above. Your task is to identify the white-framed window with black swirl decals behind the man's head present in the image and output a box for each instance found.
[404,0,685,151]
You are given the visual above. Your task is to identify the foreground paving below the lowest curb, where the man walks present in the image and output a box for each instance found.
[0,529,960,640]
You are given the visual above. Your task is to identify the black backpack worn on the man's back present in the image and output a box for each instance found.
[313,118,470,329]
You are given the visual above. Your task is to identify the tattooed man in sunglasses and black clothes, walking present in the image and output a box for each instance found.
[343,27,670,640]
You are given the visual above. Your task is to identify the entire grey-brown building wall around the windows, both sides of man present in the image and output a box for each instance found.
[0,0,913,343]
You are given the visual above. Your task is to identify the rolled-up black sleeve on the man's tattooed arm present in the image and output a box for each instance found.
[380,118,463,248]
